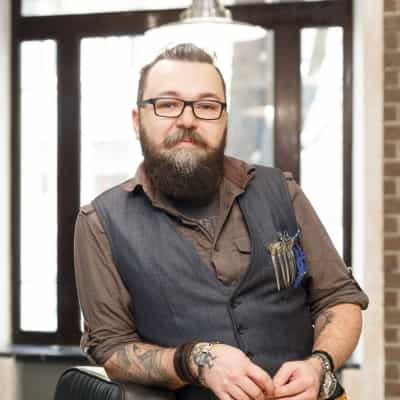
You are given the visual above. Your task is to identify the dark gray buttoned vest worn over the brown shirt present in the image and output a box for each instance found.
[93,166,313,400]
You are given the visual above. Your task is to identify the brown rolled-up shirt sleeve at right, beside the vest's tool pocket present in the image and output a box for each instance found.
[285,173,368,321]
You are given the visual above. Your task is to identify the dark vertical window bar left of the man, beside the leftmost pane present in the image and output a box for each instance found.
[57,36,80,344]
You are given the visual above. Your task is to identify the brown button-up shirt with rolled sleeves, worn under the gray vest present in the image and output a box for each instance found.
[75,157,368,364]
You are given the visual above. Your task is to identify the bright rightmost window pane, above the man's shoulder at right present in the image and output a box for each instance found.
[300,27,343,254]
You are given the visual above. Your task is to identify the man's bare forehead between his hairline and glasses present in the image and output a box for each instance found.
[145,60,224,99]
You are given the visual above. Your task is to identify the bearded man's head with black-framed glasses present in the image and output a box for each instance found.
[133,44,227,203]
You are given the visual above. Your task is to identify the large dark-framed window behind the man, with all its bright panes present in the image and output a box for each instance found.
[12,0,352,344]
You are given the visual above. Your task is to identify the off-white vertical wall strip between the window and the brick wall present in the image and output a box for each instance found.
[345,0,385,400]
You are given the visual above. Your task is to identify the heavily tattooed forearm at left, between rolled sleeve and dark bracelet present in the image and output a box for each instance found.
[104,343,182,389]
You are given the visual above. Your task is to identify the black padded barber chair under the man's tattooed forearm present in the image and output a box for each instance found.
[54,367,175,400]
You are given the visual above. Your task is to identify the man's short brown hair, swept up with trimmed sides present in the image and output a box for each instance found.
[137,43,226,102]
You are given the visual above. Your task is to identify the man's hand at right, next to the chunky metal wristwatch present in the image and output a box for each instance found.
[273,358,322,400]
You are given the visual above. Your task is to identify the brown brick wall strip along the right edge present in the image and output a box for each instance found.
[384,0,400,399]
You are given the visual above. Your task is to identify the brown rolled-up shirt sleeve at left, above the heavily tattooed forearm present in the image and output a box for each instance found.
[74,205,140,365]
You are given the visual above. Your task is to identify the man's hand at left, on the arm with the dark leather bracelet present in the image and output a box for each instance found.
[191,344,274,400]
